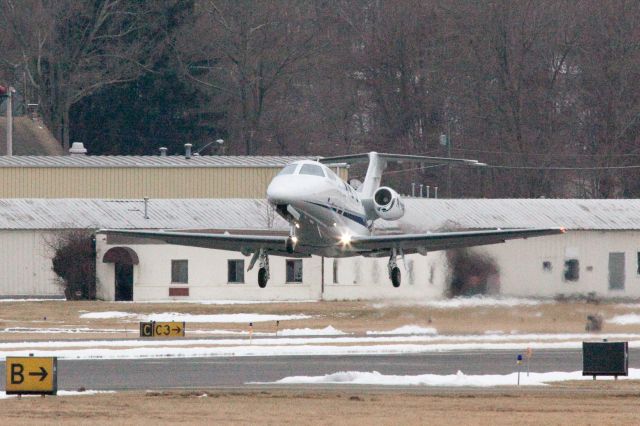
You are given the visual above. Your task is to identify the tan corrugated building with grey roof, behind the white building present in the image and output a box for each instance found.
[0,155,320,199]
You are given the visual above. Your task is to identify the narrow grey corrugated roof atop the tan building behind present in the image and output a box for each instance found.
[0,155,310,167]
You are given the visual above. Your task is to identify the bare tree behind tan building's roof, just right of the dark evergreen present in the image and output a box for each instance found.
[176,0,318,155]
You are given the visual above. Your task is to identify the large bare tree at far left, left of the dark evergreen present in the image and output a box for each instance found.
[0,0,175,150]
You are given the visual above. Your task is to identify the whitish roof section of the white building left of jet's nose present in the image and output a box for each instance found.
[0,198,288,230]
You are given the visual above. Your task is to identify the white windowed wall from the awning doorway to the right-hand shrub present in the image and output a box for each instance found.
[96,235,444,301]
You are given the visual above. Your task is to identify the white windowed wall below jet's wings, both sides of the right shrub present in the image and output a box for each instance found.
[97,231,640,301]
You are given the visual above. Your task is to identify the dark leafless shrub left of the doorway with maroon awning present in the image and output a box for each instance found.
[50,230,96,300]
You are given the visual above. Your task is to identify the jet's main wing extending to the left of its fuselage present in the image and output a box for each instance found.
[98,229,287,254]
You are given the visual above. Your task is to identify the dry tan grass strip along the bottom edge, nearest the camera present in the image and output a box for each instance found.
[0,381,640,425]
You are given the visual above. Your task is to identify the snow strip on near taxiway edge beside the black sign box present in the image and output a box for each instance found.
[268,368,640,387]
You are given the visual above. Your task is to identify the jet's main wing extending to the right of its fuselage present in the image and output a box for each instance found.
[350,228,565,254]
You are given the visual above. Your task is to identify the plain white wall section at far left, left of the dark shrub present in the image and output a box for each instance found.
[0,230,63,296]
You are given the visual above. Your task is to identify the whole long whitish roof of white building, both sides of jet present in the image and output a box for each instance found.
[0,198,640,232]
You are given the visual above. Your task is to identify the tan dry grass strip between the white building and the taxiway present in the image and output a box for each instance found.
[0,301,640,341]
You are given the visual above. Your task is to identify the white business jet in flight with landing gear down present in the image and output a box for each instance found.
[100,152,564,288]
